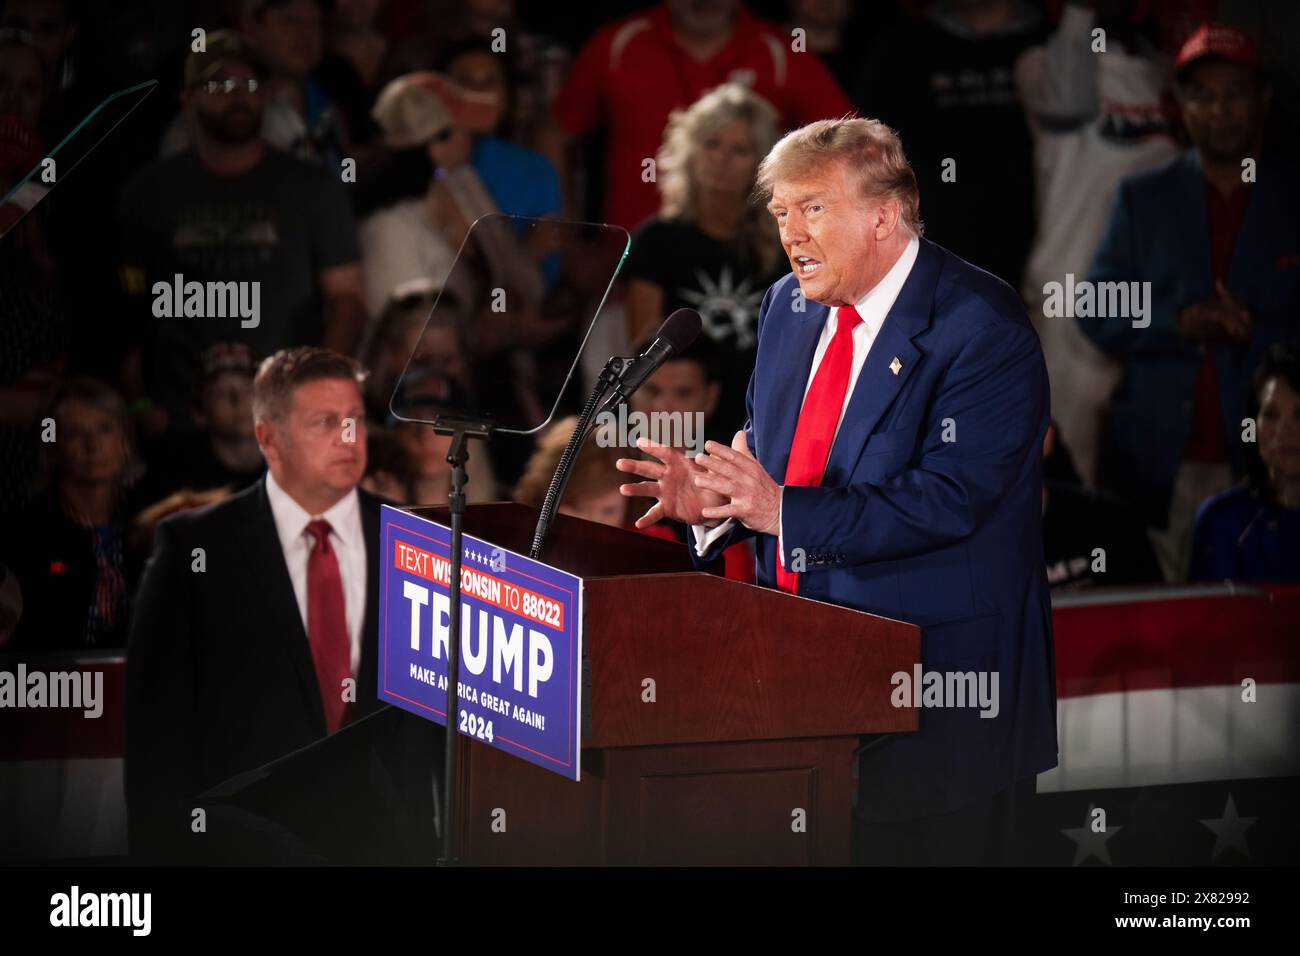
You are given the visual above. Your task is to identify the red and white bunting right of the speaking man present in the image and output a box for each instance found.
[1039,585,1300,793]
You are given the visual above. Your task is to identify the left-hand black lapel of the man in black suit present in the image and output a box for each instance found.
[241,477,325,736]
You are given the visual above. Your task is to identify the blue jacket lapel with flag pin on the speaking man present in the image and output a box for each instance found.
[822,239,941,486]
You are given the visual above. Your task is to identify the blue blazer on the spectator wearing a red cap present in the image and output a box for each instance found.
[1079,150,1300,527]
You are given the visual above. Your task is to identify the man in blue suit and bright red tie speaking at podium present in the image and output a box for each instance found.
[619,118,1057,864]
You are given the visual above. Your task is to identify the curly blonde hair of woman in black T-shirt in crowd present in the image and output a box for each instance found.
[655,83,781,269]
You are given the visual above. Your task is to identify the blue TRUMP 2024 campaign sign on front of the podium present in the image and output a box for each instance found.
[380,505,582,780]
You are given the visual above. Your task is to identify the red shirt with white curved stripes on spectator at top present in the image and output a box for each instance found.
[551,5,853,229]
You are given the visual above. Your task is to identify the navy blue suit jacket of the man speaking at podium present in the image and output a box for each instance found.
[696,239,1057,821]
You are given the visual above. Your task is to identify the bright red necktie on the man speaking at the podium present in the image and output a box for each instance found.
[776,306,862,594]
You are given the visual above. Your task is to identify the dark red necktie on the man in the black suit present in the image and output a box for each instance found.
[307,519,352,734]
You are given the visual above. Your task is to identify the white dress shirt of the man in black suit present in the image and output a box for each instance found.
[267,471,367,676]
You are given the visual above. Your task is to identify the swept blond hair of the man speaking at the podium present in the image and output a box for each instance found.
[755,117,926,235]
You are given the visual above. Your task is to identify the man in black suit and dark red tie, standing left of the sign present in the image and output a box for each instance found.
[126,347,426,858]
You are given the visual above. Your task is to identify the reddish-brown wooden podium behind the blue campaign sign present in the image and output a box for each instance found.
[410,505,920,866]
